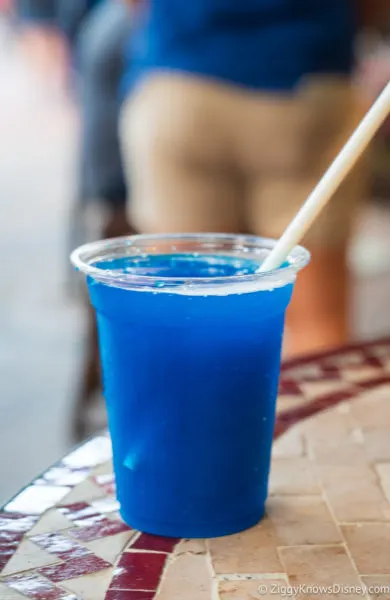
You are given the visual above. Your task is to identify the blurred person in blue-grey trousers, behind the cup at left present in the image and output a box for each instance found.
[18,0,132,439]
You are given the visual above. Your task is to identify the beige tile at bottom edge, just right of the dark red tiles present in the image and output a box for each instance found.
[156,554,212,600]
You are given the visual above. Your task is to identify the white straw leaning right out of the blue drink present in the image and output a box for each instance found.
[260,82,390,271]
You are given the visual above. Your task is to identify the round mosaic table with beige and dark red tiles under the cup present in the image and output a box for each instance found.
[0,340,390,600]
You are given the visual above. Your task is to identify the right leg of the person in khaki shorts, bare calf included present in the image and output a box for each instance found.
[247,79,365,353]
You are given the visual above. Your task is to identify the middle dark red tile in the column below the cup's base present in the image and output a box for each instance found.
[110,552,167,592]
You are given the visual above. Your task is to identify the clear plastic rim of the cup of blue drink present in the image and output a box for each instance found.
[70,233,310,288]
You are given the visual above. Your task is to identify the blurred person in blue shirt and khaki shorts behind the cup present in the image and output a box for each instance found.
[121,0,389,351]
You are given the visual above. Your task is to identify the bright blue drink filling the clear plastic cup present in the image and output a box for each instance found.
[89,255,292,537]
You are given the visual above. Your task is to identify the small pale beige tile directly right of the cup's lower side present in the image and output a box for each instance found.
[269,457,320,495]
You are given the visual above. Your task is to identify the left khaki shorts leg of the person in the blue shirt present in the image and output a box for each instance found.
[121,75,242,233]
